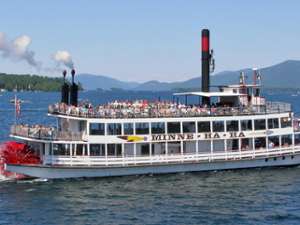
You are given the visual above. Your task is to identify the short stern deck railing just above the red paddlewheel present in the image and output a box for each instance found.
[11,124,84,141]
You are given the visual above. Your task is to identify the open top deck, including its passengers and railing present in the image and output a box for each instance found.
[48,101,292,119]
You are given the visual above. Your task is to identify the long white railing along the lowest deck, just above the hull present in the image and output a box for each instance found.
[43,146,300,166]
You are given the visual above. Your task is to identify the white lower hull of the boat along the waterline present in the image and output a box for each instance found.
[6,154,300,179]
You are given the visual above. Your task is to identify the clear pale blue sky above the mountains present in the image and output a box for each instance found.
[0,0,300,82]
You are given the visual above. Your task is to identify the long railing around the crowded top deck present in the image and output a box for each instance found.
[48,102,292,118]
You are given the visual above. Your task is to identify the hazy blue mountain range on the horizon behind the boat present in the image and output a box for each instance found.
[77,60,300,91]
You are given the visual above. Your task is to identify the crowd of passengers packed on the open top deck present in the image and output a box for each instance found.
[49,100,250,118]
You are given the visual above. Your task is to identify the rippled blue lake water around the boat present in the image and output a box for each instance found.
[0,92,300,225]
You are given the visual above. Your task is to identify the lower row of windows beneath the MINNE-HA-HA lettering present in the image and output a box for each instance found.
[53,134,300,157]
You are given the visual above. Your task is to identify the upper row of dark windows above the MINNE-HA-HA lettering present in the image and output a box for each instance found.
[90,118,292,135]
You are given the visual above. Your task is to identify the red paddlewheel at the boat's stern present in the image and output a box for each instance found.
[0,141,41,179]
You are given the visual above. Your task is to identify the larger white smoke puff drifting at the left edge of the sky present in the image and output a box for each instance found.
[0,32,41,70]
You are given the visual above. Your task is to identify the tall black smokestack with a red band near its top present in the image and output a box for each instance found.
[201,29,210,105]
